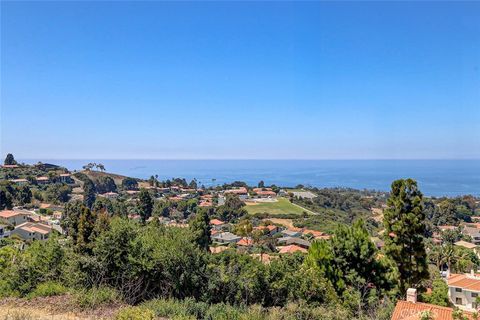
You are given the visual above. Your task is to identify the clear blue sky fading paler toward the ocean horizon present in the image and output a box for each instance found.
[0,1,480,159]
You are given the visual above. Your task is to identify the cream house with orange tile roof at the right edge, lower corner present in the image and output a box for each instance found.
[447,270,480,311]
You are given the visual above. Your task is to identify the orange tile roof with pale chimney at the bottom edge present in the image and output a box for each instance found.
[391,288,473,320]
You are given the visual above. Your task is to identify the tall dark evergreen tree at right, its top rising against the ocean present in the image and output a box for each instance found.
[383,179,429,294]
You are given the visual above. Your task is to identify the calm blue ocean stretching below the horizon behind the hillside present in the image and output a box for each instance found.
[21,159,480,197]
